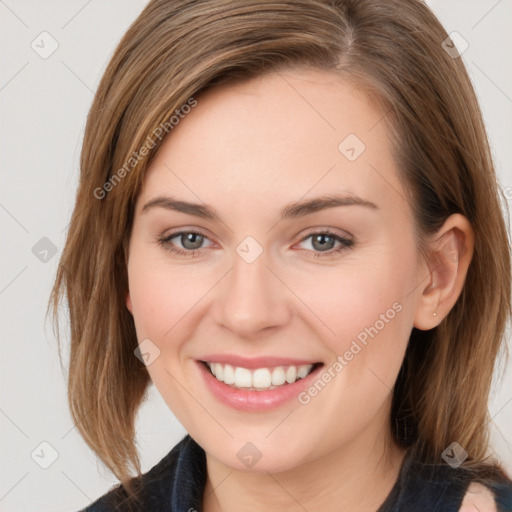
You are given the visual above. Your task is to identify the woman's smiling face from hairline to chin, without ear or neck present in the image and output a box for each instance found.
[127,70,428,471]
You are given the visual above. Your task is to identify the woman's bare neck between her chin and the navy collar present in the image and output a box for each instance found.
[203,412,405,512]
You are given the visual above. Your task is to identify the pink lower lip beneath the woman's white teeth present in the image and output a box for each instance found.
[197,361,323,411]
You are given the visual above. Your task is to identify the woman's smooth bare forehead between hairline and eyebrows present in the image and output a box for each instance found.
[134,70,403,218]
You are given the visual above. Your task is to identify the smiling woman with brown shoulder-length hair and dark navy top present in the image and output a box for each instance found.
[52,0,512,512]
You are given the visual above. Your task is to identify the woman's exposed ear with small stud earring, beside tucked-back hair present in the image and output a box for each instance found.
[414,213,475,331]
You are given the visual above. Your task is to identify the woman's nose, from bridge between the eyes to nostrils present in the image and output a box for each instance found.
[214,248,291,339]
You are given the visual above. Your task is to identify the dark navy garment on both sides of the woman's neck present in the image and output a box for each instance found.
[84,435,512,512]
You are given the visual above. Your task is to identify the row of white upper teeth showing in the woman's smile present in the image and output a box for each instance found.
[206,363,313,391]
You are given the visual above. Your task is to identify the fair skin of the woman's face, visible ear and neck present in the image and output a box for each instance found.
[126,69,474,512]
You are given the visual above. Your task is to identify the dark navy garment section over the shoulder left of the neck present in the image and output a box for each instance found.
[80,435,206,512]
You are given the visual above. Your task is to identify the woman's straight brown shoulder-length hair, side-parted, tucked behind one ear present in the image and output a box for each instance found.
[50,0,511,500]
